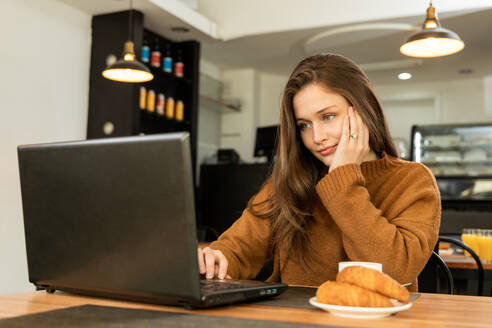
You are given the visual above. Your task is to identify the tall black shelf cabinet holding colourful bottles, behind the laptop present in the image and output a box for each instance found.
[87,10,200,173]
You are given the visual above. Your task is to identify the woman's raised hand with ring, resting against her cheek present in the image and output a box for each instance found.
[329,107,370,172]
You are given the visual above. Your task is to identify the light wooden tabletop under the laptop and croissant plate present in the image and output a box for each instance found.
[0,291,492,328]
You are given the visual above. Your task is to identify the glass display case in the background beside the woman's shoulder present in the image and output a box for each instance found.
[410,123,492,201]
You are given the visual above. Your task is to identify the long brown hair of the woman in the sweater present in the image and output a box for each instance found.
[248,54,397,266]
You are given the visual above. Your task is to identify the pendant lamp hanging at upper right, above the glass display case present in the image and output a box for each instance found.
[400,1,465,58]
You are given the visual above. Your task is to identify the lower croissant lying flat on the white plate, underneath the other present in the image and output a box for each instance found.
[316,281,393,307]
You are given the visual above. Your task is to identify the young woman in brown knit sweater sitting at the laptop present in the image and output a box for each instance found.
[198,54,441,290]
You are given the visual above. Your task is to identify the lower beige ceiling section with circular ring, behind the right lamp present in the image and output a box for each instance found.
[202,9,492,84]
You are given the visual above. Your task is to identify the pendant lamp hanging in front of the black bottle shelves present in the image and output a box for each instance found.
[102,0,154,82]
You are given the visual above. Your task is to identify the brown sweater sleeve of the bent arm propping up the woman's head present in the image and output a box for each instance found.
[316,163,441,283]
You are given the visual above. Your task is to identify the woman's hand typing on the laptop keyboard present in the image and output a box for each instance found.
[198,247,231,279]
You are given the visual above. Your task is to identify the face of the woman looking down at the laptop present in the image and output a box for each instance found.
[293,83,350,166]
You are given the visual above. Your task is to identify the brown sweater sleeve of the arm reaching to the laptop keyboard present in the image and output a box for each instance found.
[206,187,270,279]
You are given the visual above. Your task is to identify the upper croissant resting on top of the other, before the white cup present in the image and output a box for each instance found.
[337,266,410,303]
